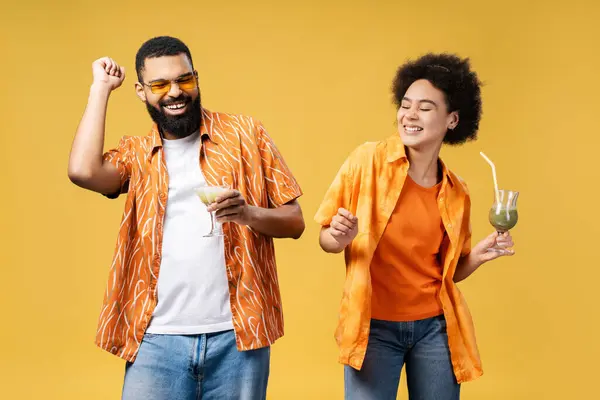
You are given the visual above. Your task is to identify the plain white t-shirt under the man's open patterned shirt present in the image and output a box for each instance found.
[147,133,233,335]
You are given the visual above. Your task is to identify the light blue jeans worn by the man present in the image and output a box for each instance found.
[122,330,270,400]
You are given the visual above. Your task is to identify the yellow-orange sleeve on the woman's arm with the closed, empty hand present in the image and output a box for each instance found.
[314,150,354,226]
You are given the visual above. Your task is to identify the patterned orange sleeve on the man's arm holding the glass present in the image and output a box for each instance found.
[256,123,302,207]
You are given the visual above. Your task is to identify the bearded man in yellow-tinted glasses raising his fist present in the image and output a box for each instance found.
[69,37,304,400]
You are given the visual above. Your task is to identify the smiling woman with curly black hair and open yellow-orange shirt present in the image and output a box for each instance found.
[315,54,513,400]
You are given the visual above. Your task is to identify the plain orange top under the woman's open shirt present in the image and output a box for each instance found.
[371,175,445,321]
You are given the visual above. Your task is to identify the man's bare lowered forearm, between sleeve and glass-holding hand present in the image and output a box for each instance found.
[248,201,304,239]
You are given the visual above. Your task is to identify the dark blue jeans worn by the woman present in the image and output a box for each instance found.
[344,315,460,400]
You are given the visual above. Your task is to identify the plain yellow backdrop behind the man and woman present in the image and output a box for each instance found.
[0,0,600,400]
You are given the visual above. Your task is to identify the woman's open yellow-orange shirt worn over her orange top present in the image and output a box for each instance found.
[315,134,483,382]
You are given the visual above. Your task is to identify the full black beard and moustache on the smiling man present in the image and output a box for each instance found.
[146,93,202,138]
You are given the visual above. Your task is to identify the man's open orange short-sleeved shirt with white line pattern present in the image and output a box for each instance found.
[96,109,302,362]
